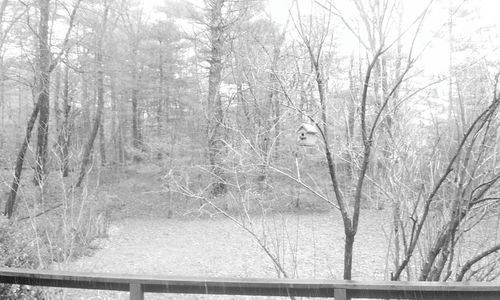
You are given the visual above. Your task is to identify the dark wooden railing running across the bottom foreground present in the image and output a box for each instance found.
[0,268,500,300]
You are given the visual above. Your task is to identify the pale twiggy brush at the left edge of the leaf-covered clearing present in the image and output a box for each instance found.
[0,168,119,300]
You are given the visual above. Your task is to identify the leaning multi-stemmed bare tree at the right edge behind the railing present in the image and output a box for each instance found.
[391,76,500,280]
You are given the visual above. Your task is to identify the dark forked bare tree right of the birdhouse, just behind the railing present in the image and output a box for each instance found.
[289,1,428,279]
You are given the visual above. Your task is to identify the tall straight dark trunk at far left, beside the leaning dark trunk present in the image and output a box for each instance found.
[33,0,51,185]
